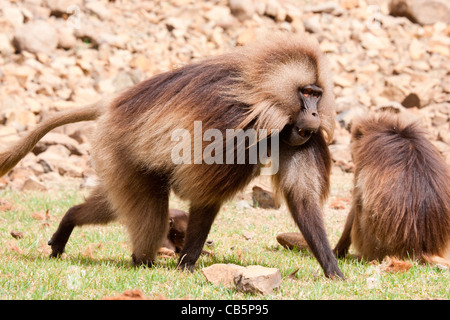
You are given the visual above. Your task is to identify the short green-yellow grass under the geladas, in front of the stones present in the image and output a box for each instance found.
[0,174,450,299]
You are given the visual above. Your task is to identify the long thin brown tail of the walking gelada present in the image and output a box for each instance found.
[0,100,107,177]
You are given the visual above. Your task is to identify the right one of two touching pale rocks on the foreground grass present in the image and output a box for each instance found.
[234,266,281,295]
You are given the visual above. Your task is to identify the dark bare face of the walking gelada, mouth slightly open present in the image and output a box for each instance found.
[282,84,323,146]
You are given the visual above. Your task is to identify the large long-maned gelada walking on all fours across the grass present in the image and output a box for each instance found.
[0,34,343,278]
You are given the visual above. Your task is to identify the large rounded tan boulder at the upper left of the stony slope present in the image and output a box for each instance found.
[13,20,58,54]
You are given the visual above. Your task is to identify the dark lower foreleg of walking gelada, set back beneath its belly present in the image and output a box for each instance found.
[178,204,221,272]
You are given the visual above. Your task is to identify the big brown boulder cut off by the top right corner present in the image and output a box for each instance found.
[389,0,450,25]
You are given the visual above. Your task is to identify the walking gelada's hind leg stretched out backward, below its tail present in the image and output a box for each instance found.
[48,188,117,257]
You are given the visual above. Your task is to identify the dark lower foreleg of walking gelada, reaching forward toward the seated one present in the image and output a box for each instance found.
[286,193,345,279]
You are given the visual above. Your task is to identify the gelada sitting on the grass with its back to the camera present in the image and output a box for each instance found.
[334,112,450,263]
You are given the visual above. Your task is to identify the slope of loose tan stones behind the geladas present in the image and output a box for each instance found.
[0,0,450,190]
